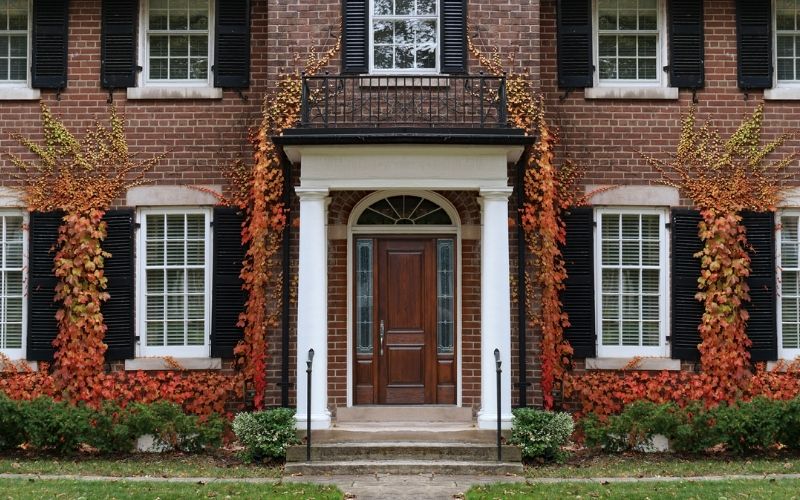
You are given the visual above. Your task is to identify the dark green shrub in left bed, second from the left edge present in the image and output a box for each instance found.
[21,397,91,453]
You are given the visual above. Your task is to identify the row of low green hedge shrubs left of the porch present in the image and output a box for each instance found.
[0,393,225,454]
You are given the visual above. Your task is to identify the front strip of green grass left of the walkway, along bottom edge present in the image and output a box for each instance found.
[0,479,343,500]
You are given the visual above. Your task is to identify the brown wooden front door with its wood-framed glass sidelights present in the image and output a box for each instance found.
[354,237,456,404]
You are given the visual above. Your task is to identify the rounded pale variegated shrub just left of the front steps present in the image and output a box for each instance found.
[233,408,300,461]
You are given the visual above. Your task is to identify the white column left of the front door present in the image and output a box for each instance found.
[295,188,331,429]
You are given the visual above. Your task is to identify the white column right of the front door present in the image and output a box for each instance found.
[478,188,512,429]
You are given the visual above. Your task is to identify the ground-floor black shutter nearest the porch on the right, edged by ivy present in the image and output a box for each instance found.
[561,207,596,358]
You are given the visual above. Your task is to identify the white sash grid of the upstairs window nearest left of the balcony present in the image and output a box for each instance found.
[139,0,215,87]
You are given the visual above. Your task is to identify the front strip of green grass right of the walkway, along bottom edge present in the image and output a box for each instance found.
[466,479,800,500]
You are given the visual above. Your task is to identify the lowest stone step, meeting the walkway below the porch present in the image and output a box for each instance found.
[284,460,522,476]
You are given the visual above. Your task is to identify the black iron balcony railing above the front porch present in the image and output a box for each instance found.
[298,75,509,129]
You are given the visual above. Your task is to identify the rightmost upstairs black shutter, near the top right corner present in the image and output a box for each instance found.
[736,0,772,89]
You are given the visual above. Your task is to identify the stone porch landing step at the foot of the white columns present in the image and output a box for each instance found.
[297,422,511,444]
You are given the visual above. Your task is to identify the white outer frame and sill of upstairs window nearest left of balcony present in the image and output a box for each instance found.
[127,0,222,99]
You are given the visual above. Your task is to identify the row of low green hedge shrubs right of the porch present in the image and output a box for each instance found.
[581,397,800,455]
